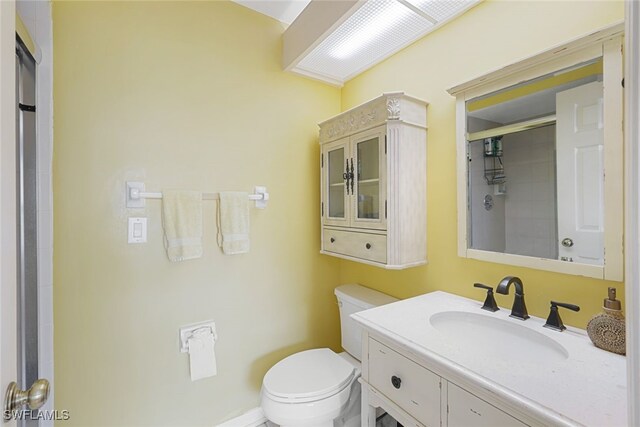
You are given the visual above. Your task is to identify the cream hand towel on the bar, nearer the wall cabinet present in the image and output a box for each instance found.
[218,191,249,255]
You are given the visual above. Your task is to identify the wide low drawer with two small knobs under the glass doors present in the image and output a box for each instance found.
[322,228,387,263]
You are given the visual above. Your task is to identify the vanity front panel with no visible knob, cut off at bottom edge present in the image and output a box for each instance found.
[447,383,526,427]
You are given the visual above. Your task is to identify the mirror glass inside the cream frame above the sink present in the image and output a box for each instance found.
[466,59,604,265]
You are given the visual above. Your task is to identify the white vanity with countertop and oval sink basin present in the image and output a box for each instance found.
[351,291,628,427]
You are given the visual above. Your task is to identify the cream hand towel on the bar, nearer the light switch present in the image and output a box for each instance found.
[162,190,202,261]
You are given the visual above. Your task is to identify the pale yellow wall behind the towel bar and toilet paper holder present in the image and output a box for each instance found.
[53,1,340,426]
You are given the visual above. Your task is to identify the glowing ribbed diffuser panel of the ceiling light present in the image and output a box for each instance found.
[293,0,480,84]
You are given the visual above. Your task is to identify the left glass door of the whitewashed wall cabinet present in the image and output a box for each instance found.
[323,139,349,226]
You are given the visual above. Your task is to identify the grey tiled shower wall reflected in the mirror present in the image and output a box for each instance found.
[469,120,558,258]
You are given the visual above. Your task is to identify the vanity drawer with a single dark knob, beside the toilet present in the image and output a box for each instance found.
[369,338,440,427]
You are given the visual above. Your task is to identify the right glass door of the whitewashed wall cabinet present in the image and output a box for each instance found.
[352,129,386,228]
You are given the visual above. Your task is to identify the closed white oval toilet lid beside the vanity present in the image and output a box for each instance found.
[263,348,355,399]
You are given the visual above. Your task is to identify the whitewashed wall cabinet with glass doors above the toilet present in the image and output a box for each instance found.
[320,92,427,269]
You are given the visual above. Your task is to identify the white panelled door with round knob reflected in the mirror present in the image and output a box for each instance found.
[556,82,604,265]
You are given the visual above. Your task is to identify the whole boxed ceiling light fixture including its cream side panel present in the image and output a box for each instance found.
[283,0,481,86]
